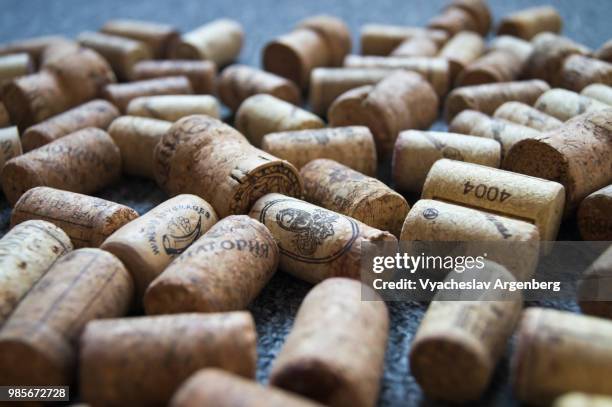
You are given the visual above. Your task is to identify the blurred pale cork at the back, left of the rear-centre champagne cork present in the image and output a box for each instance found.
[174,18,244,67]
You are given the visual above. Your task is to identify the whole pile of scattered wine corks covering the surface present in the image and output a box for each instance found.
[0,0,612,407]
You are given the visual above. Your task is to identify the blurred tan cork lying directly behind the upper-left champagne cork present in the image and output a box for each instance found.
[77,31,153,80]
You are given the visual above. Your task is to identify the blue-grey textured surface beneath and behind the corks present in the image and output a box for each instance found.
[0,0,612,406]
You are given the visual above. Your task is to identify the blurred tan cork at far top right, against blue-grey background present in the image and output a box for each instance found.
[497,6,563,40]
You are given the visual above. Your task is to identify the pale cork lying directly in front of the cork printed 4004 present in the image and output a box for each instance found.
[400,199,540,281]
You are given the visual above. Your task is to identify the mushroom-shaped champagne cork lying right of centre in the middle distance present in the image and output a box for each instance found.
[328,71,438,157]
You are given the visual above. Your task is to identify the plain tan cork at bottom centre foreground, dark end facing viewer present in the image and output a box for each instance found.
[270,278,389,407]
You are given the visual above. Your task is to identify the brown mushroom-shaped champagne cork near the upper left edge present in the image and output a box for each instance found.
[1,48,115,130]
